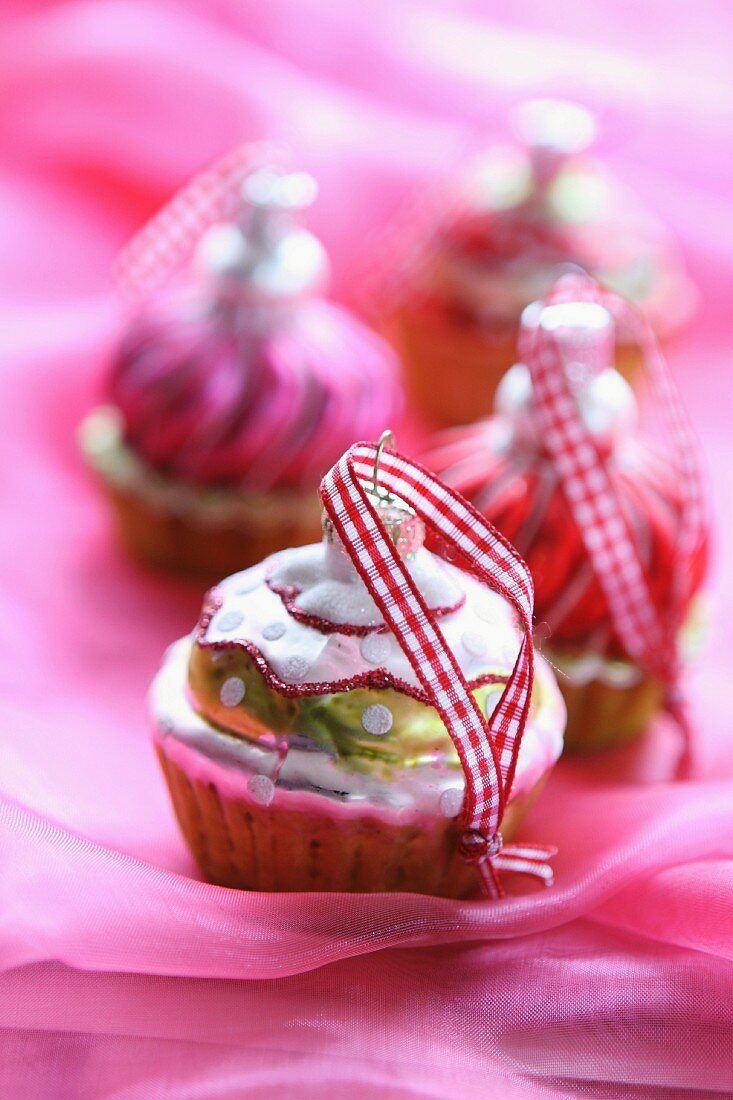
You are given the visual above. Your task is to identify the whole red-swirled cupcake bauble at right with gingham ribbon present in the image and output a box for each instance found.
[426,278,708,749]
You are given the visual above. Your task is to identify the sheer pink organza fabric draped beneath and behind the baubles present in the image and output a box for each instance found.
[0,0,733,1100]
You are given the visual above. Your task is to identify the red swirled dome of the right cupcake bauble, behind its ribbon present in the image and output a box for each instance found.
[424,417,708,658]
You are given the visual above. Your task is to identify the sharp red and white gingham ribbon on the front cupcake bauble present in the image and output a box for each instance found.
[320,443,554,898]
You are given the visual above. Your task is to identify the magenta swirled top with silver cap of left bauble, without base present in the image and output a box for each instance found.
[109,161,400,493]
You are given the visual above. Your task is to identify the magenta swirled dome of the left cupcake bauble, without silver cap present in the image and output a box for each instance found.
[109,293,401,491]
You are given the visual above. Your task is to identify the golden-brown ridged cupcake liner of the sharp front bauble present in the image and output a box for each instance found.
[155,735,543,898]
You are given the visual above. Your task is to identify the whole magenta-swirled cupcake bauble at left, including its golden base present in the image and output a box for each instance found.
[83,164,400,579]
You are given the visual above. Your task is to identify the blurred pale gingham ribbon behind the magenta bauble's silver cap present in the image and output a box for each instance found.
[114,142,283,301]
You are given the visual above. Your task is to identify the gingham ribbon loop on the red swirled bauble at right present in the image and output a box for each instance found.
[521,274,705,729]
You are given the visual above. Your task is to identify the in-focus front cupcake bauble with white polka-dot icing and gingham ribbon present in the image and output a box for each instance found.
[152,433,565,897]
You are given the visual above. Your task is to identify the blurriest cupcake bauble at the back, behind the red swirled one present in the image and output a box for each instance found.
[384,100,693,426]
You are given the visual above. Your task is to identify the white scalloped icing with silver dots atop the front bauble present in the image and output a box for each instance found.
[205,543,521,688]
